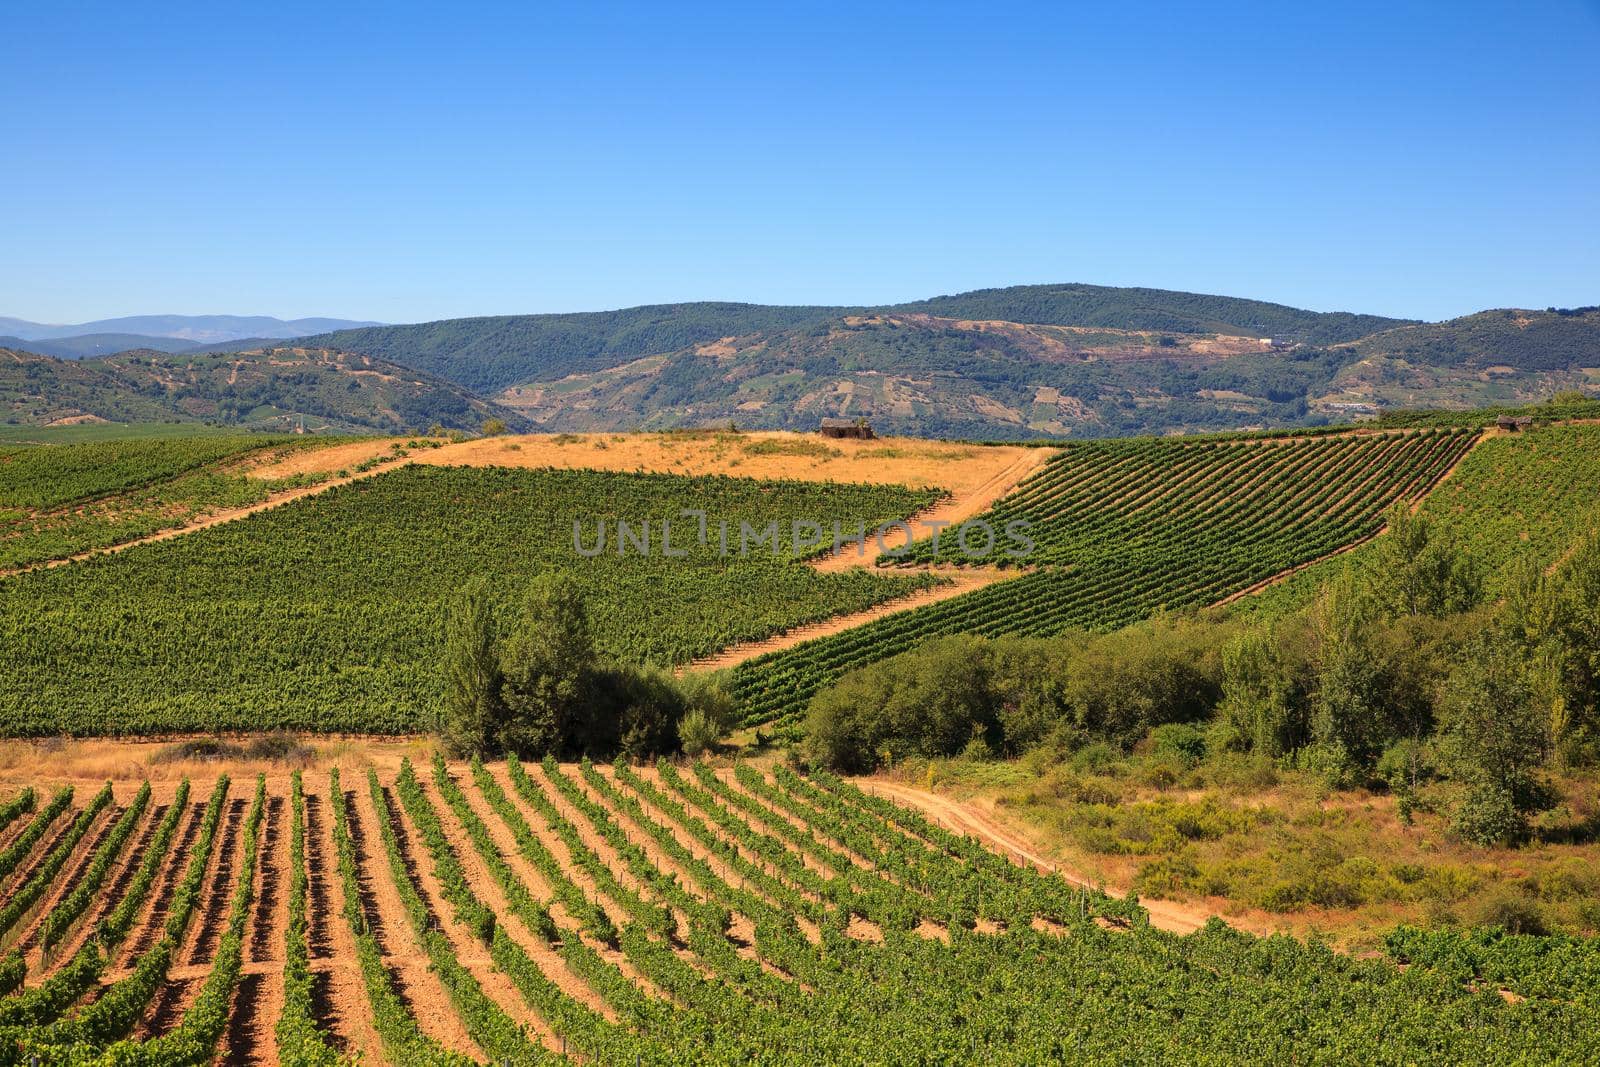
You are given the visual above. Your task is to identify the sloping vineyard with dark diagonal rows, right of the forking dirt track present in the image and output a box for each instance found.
[734,429,1477,723]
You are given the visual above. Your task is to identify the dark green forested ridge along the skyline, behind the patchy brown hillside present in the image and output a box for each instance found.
[291,285,1405,392]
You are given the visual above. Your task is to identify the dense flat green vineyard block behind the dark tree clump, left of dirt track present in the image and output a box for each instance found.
[0,466,936,736]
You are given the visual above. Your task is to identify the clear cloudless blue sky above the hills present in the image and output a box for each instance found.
[0,0,1600,322]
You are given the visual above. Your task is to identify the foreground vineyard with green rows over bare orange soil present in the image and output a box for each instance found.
[0,760,1600,1065]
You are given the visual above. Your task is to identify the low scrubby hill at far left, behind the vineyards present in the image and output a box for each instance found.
[0,347,528,434]
